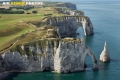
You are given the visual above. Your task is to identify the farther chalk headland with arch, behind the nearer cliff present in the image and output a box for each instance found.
[46,16,94,37]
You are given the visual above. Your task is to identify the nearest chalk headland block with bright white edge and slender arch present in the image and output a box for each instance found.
[54,38,98,73]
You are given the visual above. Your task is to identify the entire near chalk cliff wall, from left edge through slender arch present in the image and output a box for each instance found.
[0,38,98,73]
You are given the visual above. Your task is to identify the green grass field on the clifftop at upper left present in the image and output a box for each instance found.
[0,7,65,50]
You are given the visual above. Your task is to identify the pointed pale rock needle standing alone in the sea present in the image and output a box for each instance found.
[100,42,110,62]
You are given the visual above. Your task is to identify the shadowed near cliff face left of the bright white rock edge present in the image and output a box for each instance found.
[1,41,54,72]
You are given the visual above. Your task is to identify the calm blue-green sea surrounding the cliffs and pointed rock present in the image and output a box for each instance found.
[4,1,120,80]
